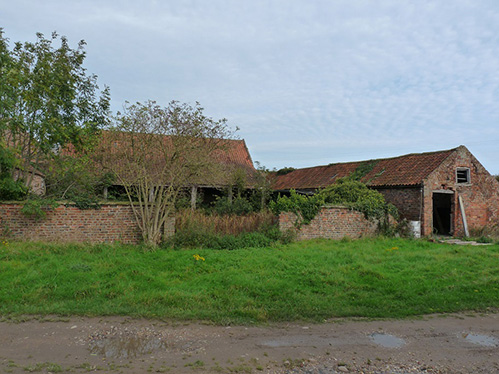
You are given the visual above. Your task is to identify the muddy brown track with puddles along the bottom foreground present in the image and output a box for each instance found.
[0,313,499,373]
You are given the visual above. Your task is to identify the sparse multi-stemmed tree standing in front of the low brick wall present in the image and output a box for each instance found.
[96,101,237,246]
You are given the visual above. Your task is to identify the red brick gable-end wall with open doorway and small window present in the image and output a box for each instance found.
[422,147,499,236]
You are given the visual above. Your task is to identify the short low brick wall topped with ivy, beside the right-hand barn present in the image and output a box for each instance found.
[279,206,378,240]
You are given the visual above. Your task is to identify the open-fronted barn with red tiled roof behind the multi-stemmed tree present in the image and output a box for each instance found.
[88,131,257,208]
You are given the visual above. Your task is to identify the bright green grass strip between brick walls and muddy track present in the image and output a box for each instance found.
[0,238,499,324]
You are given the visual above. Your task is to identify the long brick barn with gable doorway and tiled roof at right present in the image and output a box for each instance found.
[273,146,499,236]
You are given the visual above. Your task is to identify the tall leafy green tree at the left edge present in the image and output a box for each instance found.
[0,29,109,191]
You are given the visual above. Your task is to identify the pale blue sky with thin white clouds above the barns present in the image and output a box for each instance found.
[0,0,499,174]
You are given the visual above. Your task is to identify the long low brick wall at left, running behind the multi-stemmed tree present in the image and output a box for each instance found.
[0,203,175,244]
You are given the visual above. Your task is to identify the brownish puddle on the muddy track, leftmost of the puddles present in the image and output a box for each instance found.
[90,335,166,358]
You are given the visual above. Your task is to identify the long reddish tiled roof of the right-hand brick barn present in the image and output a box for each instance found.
[273,148,456,190]
